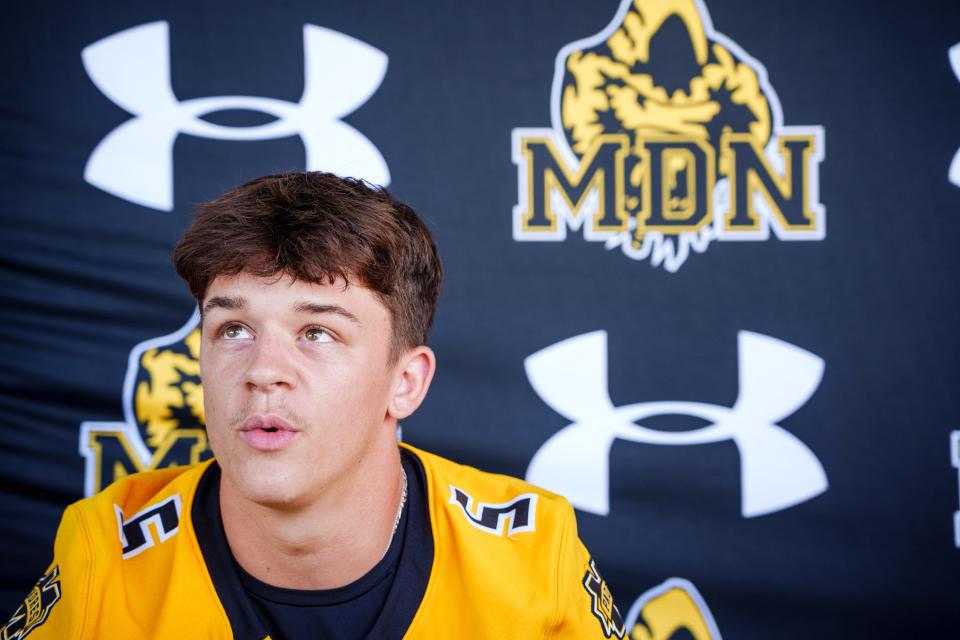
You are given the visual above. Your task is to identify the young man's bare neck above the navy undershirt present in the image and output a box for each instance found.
[220,439,403,589]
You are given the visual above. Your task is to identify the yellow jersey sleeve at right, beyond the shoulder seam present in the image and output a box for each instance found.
[549,505,625,640]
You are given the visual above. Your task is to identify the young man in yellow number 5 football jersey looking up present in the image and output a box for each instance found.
[2,173,624,640]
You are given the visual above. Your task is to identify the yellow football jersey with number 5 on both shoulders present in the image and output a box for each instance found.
[0,445,624,640]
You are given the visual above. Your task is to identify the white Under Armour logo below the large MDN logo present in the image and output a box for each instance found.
[524,331,828,518]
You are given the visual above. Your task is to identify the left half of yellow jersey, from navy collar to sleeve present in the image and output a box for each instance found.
[3,461,230,640]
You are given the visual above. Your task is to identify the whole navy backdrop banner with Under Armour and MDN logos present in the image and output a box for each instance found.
[0,0,960,640]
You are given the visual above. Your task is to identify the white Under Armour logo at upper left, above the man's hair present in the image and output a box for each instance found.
[82,21,390,211]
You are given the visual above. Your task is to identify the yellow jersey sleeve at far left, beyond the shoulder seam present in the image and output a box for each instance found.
[0,506,93,640]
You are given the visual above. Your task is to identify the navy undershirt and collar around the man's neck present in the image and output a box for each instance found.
[193,451,433,640]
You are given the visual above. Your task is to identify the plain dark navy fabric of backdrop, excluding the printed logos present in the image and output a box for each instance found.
[0,0,960,640]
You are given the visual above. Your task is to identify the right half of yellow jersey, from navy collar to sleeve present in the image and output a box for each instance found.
[404,445,623,640]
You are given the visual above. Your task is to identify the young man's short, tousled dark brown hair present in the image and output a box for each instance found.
[173,172,443,360]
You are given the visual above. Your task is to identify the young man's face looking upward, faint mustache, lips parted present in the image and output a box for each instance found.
[200,273,402,507]
